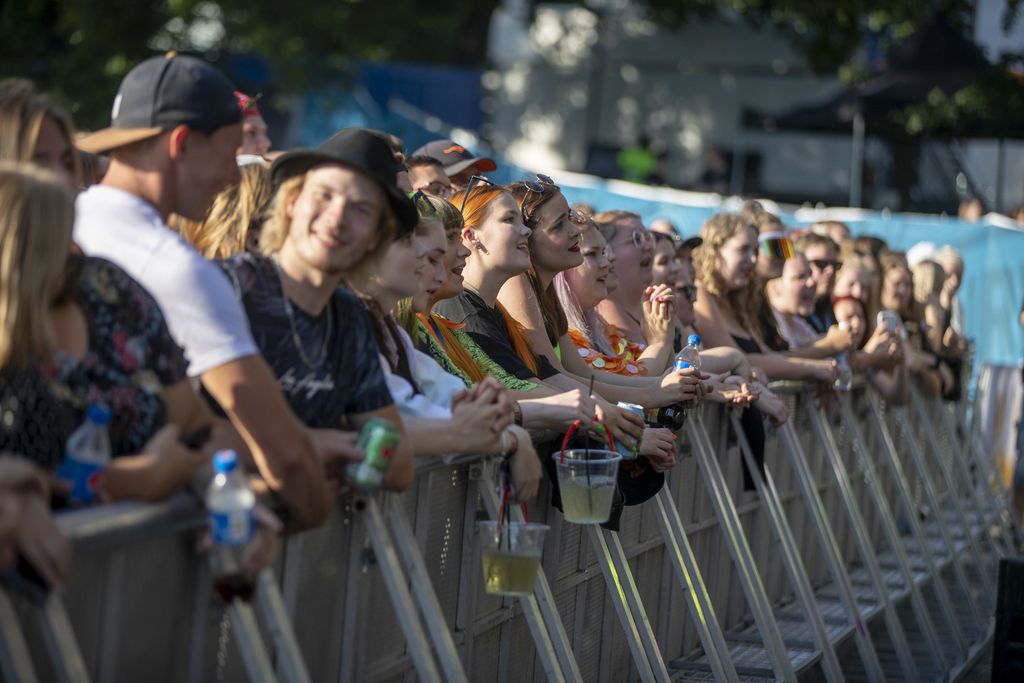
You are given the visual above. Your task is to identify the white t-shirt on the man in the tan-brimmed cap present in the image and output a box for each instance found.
[75,185,259,377]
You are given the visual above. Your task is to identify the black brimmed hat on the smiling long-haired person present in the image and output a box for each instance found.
[270,128,419,237]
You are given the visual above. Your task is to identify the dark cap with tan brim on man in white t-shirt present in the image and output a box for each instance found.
[76,52,242,154]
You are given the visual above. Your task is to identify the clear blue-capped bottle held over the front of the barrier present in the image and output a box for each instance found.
[206,451,256,602]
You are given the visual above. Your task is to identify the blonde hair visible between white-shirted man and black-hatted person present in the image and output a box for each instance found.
[177,164,270,258]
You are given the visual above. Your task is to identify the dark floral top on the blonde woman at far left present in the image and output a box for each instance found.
[40,258,187,456]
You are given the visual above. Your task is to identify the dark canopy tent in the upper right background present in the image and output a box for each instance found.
[742,17,1024,206]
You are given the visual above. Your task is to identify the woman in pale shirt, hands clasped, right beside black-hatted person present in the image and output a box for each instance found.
[348,193,542,500]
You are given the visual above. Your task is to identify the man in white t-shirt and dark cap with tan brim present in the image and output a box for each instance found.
[75,53,331,527]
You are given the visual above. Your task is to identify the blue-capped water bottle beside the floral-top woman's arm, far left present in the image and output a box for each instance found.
[57,403,111,505]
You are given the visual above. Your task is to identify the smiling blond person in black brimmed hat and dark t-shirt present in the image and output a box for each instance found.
[221,128,418,489]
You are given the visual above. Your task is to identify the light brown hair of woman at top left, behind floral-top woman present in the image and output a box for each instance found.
[0,78,82,184]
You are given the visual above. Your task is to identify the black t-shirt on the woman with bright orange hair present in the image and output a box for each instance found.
[434,290,558,380]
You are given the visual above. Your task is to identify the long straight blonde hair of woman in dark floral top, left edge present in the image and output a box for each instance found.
[0,160,75,368]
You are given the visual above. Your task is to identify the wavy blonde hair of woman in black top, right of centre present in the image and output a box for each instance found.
[693,213,760,337]
